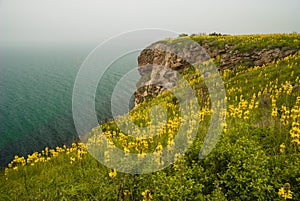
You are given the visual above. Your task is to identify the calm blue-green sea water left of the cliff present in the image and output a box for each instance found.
[0,45,137,166]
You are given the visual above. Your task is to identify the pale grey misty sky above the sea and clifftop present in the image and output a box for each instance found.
[0,0,300,43]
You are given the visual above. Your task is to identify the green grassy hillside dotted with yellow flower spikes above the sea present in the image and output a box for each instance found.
[0,34,300,201]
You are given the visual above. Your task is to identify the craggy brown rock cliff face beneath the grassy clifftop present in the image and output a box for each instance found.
[135,37,298,105]
